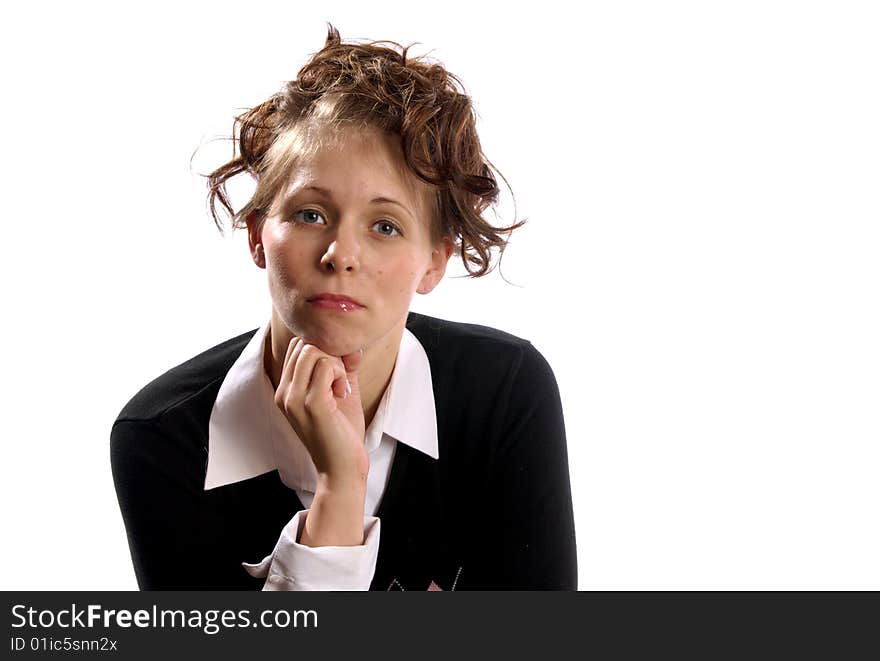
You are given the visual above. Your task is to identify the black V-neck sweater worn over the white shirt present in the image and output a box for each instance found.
[110,313,577,590]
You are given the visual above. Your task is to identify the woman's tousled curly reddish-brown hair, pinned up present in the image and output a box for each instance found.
[208,24,525,277]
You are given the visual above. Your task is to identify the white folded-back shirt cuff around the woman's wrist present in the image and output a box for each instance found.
[241,510,380,591]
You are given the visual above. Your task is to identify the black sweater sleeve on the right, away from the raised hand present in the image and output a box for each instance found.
[474,343,577,590]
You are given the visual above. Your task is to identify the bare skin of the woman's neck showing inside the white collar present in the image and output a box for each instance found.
[263,310,406,427]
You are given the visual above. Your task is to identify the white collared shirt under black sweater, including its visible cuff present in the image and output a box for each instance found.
[205,322,439,590]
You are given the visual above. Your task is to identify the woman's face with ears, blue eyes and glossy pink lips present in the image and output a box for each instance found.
[248,129,451,356]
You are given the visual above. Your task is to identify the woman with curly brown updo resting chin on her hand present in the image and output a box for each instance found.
[111,26,577,590]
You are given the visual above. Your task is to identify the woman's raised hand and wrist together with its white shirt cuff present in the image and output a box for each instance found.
[248,338,380,590]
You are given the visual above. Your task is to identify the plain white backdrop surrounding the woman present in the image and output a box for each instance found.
[0,1,880,590]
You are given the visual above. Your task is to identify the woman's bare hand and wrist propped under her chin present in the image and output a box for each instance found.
[275,337,370,546]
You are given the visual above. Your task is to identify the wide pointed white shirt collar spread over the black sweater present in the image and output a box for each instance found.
[205,322,439,492]
